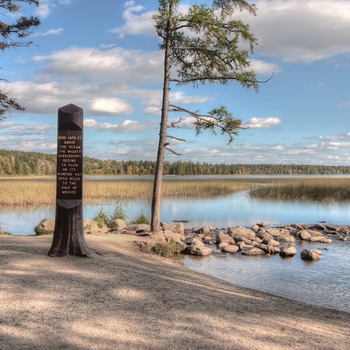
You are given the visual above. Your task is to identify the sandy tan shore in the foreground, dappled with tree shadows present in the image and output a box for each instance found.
[0,235,350,350]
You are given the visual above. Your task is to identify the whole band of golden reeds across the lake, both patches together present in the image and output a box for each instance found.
[0,178,350,205]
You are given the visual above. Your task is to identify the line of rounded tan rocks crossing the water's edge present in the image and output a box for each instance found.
[34,219,350,261]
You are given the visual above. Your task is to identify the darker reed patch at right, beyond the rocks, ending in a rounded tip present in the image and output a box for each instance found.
[250,178,350,202]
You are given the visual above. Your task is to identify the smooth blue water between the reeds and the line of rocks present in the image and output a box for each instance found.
[0,191,350,235]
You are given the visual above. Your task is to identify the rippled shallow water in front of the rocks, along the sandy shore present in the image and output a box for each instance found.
[183,240,350,312]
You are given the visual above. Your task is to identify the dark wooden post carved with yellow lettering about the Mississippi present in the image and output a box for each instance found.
[49,104,89,256]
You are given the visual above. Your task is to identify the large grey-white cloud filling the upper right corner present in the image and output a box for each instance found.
[250,0,350,62]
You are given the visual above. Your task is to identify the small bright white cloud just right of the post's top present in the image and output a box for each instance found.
[90,98,133,115]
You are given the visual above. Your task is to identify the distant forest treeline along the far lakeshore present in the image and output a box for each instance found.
[0,150,350,176]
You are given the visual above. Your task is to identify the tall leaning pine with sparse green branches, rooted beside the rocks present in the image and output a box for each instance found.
[151,0,258,231]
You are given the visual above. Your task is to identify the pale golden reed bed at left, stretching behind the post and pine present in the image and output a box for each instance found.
[0,179,253,205]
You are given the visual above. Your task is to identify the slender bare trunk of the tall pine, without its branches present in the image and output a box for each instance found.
[151,2,173,232]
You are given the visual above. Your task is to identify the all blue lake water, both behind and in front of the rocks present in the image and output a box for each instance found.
[0,178,350,312]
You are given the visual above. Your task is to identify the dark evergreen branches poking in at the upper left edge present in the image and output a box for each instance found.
[0,0,40,121]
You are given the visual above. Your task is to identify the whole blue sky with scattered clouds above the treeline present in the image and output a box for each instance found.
[0,0,350,165]
